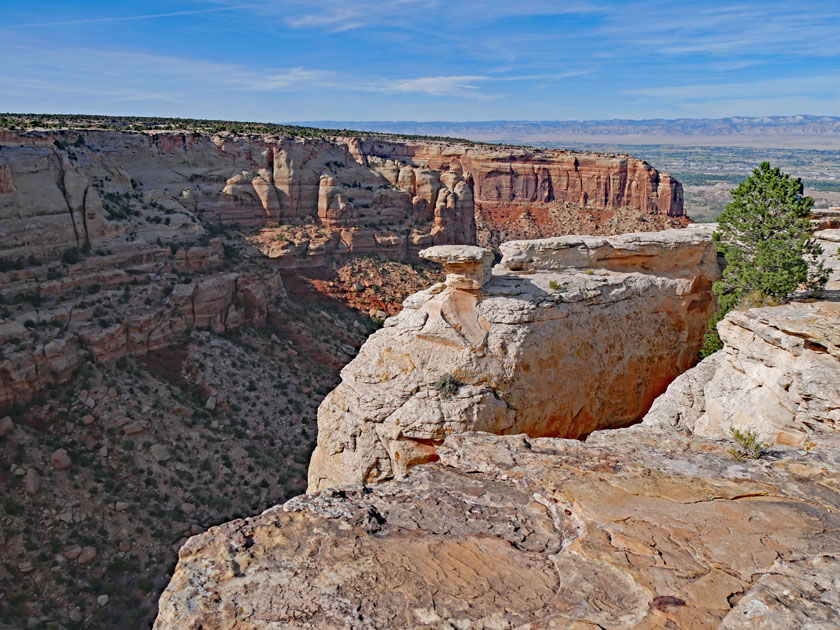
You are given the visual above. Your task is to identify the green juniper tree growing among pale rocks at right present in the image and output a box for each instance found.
[700,162,828,358]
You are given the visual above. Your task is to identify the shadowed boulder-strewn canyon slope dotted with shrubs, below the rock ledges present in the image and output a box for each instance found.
[0,303,366,628]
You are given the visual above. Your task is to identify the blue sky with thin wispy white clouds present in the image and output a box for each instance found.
[0,0,840,122]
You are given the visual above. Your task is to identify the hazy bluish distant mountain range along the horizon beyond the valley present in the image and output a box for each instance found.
[293,115,840,150]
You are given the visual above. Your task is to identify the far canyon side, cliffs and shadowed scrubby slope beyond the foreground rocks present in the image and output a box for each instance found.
[0,117,686,630]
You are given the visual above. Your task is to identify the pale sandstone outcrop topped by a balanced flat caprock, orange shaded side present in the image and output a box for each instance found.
[309,226,718,491]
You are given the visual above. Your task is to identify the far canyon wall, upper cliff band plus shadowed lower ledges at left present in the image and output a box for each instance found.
[0,129,686,409]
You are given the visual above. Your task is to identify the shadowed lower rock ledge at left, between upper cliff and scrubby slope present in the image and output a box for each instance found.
[0,239,285,409]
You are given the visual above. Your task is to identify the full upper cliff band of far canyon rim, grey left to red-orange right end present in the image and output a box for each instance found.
[0,130,685,267]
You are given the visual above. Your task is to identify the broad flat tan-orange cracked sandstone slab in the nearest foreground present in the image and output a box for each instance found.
[154,426,840,630]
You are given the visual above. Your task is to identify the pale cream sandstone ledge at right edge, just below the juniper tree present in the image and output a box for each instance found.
[645,302,840,445]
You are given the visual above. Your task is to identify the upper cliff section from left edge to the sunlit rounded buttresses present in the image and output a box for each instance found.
[0,130,475,266]
